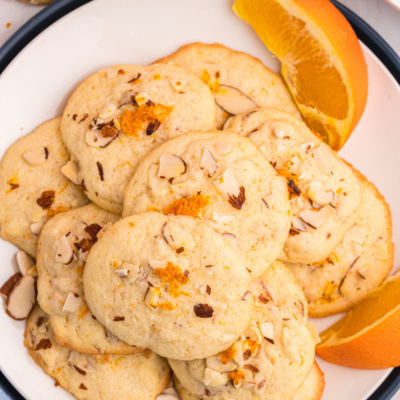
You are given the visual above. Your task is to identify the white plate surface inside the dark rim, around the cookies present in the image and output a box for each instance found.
[0,0,400,400]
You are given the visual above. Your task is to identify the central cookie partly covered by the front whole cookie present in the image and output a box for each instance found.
[123,131,291,277]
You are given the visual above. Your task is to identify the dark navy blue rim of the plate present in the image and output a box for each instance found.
[0,0,400,400]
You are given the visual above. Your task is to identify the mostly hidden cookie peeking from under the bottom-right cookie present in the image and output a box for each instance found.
[173,361,325,400]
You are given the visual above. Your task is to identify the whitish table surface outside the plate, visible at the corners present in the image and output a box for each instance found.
[0,0,400,400]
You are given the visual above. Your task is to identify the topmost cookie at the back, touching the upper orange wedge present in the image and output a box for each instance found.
[157,43,300,129]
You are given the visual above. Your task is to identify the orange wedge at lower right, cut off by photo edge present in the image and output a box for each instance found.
[316,277,400,369]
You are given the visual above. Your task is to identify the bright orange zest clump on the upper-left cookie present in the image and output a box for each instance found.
[120,104,173,138]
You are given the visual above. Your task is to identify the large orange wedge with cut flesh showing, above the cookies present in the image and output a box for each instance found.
[233,0,368,150]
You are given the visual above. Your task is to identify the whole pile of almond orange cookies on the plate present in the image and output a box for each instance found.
[0,43,393,400]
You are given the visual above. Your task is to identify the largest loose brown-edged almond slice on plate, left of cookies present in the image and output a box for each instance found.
[6,275,36,320]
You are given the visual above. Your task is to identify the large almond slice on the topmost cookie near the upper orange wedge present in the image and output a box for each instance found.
[214,85,257,115]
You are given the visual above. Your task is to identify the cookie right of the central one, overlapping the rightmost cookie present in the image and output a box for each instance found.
[224,108,361,263]
